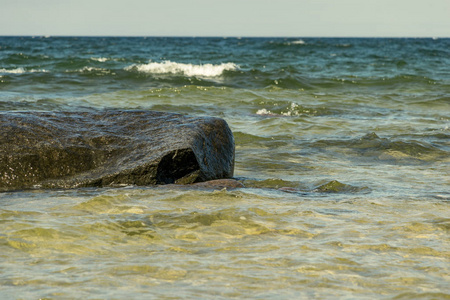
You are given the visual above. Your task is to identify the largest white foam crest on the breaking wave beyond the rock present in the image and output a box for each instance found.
[125,60,239,77]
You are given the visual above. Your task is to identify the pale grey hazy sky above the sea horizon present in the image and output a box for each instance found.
[0,0,450,37]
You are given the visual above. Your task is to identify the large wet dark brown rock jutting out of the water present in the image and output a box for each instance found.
[0,111,234,191]
